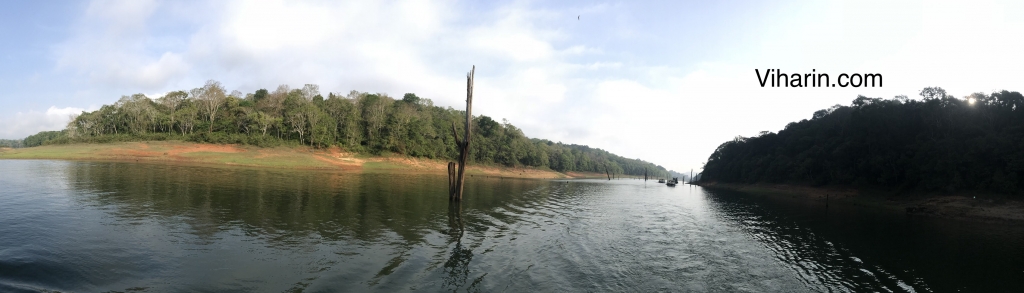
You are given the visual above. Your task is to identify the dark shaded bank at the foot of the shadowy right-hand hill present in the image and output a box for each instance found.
[700,182,1024,223]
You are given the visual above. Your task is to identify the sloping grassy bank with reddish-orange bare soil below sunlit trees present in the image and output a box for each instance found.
[0,141,569,178]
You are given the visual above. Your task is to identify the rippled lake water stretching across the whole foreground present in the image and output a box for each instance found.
[0,160,1024,292]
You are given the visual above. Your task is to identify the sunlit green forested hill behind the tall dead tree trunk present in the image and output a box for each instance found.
[34,81,668,177]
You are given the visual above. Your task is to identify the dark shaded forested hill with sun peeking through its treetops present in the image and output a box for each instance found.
[701,88,1024,194]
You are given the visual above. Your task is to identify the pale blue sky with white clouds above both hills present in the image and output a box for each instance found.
[0,0,1024,171]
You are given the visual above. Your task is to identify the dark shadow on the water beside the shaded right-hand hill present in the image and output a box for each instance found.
[707,186,1024,292]
